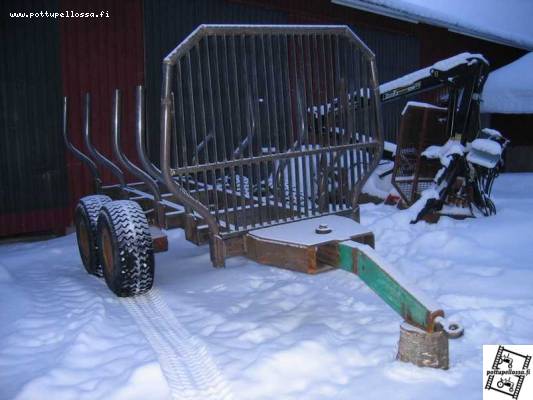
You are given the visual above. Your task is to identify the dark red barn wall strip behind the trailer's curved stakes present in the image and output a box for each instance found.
[60,0,144,221]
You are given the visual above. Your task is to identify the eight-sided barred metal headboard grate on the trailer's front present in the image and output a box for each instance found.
[161,25,383,235]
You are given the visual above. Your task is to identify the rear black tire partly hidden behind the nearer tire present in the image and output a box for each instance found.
[74,194,111,276]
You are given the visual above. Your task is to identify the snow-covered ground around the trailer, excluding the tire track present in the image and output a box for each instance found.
[0,174,533,400]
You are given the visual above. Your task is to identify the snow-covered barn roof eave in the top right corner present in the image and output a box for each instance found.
[331,0,533,50]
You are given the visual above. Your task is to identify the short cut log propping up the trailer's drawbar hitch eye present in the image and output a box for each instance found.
[396,322,449,369]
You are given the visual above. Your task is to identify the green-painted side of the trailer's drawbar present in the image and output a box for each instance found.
[357,251,430,328]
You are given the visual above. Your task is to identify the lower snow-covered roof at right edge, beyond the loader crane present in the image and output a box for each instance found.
[481,52,533,114]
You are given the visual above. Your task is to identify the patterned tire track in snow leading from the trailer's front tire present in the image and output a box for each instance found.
[121,289,233,400]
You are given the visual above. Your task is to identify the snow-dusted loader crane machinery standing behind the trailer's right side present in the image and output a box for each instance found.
[380,53,507,222]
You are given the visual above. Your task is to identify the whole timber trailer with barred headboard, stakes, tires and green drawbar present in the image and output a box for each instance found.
[63,25,461,368]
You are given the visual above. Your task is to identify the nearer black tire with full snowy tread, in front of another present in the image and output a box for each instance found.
[98,200,155,297]
